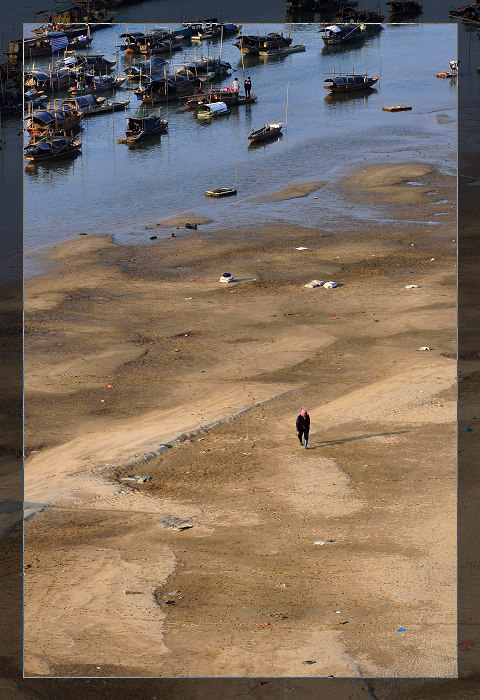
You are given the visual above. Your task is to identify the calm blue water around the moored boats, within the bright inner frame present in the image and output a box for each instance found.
[24,23,457,275]
